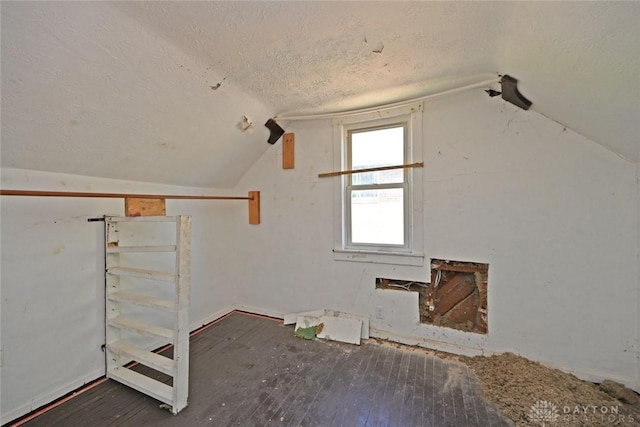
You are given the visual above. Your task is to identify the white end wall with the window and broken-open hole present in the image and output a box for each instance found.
[236,90,640,389]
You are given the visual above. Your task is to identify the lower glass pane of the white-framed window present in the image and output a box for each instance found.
[351,188,404,245]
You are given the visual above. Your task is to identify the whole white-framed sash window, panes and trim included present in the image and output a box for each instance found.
[334,104,424,265]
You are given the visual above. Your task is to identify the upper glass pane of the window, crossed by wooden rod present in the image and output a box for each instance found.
[351,126,405,185]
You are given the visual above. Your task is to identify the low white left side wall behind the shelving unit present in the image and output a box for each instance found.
[0,169,240,423]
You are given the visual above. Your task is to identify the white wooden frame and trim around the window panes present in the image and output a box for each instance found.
[333,103,424,266]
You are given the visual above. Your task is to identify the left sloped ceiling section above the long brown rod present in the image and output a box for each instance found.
[1,2,274,188]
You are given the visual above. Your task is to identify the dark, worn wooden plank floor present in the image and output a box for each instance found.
[17,313,513,427]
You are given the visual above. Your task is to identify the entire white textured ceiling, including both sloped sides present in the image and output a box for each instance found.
[1,1,640,187]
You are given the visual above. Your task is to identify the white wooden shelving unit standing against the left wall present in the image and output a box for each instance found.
[105,215,191,414]
